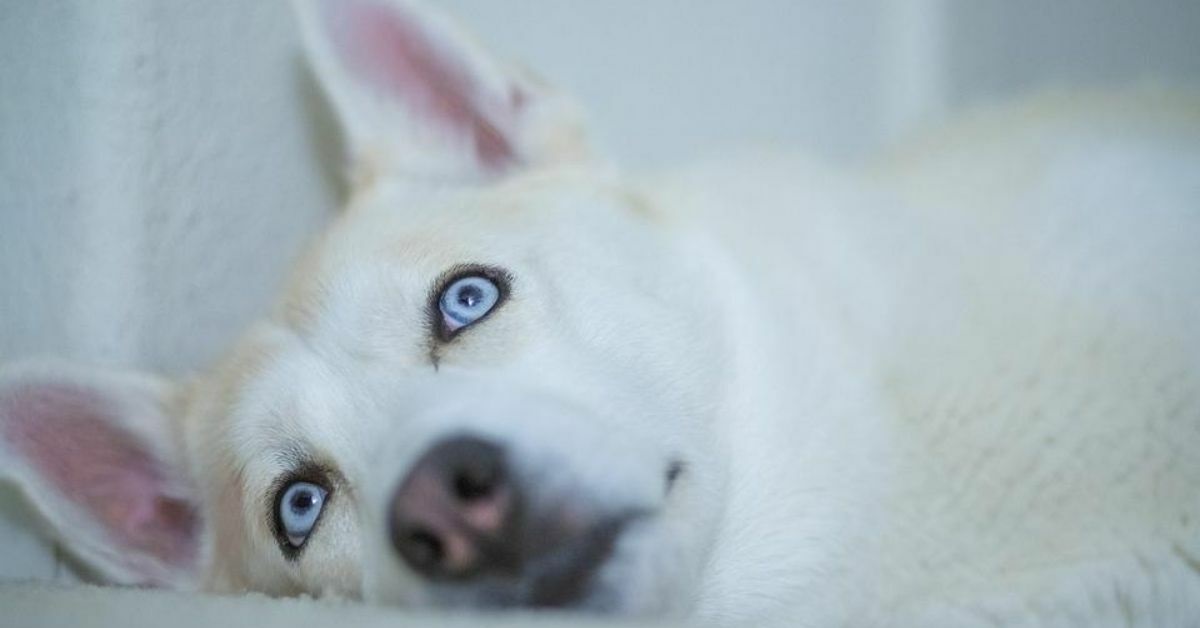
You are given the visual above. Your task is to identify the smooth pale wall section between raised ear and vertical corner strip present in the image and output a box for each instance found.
[443,0,888,166]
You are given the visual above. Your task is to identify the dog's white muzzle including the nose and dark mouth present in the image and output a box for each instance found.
[362,372,678,614]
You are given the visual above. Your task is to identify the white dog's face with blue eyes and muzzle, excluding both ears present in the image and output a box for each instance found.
[188,163,715,610]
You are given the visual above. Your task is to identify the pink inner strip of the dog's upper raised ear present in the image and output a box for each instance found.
[324,0,526,171]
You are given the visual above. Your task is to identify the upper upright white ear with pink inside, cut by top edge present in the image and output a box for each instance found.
[295,0,587,183]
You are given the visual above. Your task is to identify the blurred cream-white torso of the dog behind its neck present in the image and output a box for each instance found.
[854,94,1200,626]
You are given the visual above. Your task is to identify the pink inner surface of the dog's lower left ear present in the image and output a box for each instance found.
[0,384,199,567]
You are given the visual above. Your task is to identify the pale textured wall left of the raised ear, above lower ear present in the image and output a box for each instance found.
[0,0,332,372]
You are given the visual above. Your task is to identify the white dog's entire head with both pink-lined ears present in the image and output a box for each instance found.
[0,0,724,612]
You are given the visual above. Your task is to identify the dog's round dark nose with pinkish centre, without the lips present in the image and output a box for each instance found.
[391,436,520,579]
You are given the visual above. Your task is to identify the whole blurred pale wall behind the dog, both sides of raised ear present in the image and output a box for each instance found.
[0,0,1200,578]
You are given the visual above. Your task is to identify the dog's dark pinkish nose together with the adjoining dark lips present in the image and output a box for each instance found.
[390,436,635,606]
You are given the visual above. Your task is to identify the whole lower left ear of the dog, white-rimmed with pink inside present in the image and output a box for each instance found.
[0,363,202,587]
